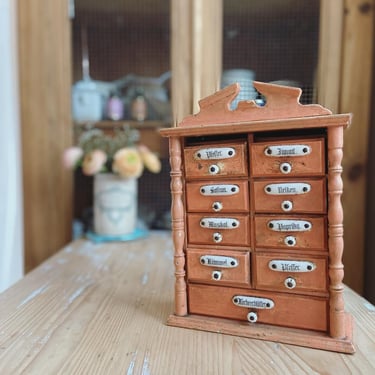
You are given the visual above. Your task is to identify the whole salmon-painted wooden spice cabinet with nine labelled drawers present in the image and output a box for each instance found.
[161,82,355,353]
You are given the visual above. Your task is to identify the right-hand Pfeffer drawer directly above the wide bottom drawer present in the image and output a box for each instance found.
[255,253,327,293]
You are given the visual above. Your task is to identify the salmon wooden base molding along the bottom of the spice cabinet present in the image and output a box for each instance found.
[167,314,355,354]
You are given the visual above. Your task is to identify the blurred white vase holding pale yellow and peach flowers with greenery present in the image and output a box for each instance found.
[63,126,161,236]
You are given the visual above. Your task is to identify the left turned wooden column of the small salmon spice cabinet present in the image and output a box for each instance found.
[169,137,187,316]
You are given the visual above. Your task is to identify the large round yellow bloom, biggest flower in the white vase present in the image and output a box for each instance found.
[112,147,143,178]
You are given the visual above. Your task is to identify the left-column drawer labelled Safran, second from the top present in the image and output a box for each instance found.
[186,180,249,212]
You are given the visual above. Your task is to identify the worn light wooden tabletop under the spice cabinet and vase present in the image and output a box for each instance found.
[0,231,375,375]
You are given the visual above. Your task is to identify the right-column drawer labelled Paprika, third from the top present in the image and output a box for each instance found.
[254,215,327,250]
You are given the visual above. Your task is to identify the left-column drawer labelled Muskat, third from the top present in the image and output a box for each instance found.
[187,214,250,246]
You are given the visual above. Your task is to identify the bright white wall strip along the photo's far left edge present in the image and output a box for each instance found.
[0,0,23,292]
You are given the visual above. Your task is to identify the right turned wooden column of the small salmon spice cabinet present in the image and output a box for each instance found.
[328,126,346,339]
